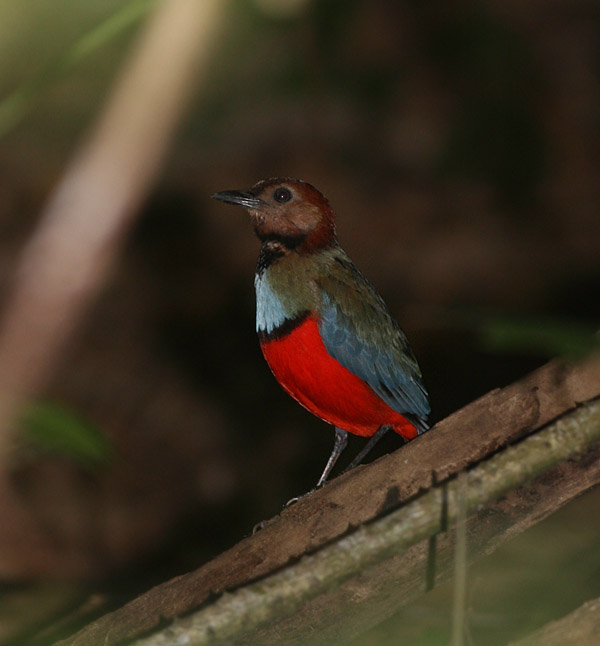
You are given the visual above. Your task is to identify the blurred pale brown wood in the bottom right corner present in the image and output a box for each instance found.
[509,599,600,646]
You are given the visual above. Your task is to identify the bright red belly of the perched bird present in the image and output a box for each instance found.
[261,317,417,439]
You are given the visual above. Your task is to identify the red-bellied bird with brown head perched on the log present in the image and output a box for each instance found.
[212,177,431,501]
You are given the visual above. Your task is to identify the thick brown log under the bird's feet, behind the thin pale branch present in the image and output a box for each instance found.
[57,361,600,646]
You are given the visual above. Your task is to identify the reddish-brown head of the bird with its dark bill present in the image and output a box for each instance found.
[212,177,337,253]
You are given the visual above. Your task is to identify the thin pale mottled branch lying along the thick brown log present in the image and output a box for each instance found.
[135,402,600,646]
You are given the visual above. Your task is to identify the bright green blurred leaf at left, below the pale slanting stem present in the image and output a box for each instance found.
[20,401,112,467]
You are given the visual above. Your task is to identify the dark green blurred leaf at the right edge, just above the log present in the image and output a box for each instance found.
[479,316,600,359]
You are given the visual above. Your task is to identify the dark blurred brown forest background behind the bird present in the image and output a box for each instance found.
[0,0,600,644]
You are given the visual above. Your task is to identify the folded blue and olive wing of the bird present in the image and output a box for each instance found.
[318,250,431,433]
